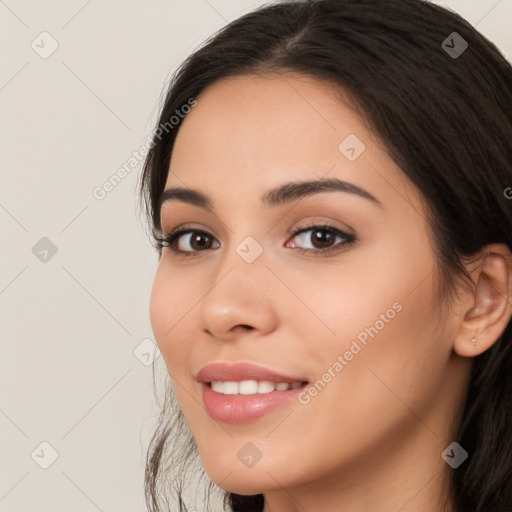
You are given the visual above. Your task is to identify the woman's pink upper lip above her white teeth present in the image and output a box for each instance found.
[196,362,307,384]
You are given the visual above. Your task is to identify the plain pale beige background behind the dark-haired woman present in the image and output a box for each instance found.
[0,0,512,512]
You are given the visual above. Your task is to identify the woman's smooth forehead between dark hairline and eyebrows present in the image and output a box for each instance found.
[166,74,424,214]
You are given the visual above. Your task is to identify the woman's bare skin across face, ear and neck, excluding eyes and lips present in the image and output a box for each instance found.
[150,74,511,512]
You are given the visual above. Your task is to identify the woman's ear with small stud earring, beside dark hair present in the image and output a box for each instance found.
[453,244,512,357]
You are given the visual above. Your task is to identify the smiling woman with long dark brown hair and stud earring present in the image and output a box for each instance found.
[141,0,512,512]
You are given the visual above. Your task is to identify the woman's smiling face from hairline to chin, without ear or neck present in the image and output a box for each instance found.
[151,74,462,494]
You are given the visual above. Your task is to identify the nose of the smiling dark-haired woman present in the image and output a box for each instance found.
[200,251,278,341]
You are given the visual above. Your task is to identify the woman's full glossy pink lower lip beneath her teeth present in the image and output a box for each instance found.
[200,383,306,423]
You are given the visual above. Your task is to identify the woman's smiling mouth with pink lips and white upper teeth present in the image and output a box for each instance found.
[196,363,309,423]
